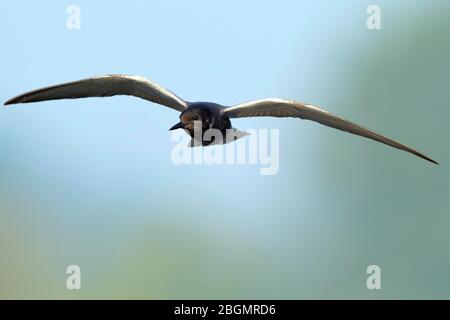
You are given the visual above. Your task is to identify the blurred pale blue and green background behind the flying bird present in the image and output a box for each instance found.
[0,0,450,299]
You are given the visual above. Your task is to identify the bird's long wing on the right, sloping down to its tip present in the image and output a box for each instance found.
[224,98,438,164]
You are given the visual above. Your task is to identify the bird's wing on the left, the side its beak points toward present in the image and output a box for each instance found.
[5,75,187,111]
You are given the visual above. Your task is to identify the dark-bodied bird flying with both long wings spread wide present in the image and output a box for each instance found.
[4,74,438,164]
